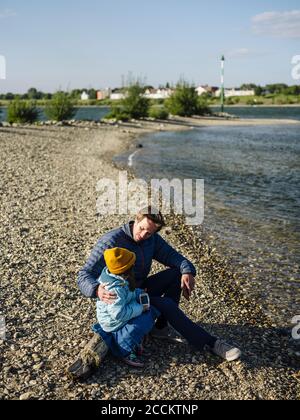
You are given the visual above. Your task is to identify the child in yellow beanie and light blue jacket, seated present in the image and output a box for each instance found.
[94,248,159,367]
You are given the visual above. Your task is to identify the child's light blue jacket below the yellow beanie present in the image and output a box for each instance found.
[97,268,143,332]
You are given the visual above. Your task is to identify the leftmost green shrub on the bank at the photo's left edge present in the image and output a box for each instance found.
[7,98,39,124]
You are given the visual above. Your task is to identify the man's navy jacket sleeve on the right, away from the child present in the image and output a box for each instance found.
[153,234,196,276]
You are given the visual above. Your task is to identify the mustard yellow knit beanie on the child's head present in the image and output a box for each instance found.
[104,248,136,274]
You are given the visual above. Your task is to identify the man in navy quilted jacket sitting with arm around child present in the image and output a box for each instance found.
[69,207,241,380]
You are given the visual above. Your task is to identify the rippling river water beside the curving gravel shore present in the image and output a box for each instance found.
[115,125,300,325]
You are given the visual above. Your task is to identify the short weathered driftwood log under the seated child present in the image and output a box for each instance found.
[67,334,108,381]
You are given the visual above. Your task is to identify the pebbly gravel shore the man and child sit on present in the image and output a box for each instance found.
[0,119,300,400]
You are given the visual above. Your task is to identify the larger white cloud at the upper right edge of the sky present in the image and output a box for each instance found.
[252,10,300,38]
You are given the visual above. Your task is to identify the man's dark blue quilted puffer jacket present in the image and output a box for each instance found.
[78,222,196,298]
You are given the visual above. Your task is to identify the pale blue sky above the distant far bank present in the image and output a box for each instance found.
[0,0,300,93]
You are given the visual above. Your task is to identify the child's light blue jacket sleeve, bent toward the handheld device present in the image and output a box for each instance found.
[107,288,143,322]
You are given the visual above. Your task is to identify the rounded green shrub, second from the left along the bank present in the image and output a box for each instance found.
[45,92,76,121]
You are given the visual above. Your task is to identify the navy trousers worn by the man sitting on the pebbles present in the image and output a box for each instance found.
[138,268,216,351]
